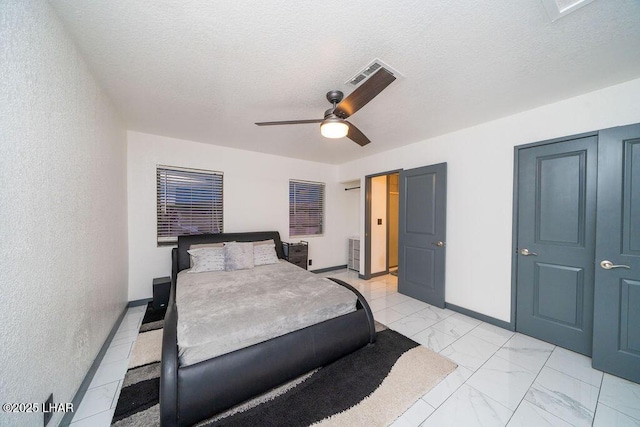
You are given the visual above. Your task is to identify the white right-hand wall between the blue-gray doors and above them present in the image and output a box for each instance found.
[339,79,640,321]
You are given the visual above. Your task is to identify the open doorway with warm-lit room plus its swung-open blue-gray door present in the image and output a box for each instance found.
[363,163,447,308]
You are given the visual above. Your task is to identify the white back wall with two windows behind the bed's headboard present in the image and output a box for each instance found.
[127,131,348,300]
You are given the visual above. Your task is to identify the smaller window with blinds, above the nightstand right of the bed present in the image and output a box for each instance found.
[289,180,324,236]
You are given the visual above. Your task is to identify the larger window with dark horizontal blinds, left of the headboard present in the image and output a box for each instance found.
[156,166,222,244]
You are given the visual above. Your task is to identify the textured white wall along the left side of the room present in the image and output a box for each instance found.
[0,0,127,426]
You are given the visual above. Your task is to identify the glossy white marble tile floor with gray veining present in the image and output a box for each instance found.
[71,270,640,427]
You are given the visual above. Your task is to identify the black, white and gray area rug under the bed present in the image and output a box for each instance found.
[112,309,456,427]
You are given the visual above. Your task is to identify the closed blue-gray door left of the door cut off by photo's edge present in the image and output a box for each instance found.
[516,135,598,355]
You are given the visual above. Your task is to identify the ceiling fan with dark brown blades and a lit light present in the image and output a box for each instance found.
[256,68,396,146]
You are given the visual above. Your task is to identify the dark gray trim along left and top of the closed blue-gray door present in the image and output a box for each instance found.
[509,131,598,331]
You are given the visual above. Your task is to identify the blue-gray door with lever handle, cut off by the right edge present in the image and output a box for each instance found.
[593,125,640,382]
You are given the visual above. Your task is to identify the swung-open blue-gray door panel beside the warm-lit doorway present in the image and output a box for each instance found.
[398,163,447,308]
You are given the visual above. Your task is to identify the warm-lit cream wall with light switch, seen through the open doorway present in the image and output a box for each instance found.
[371,175,387,274]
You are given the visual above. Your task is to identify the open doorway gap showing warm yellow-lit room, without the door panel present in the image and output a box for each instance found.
[364,171,400,278]
